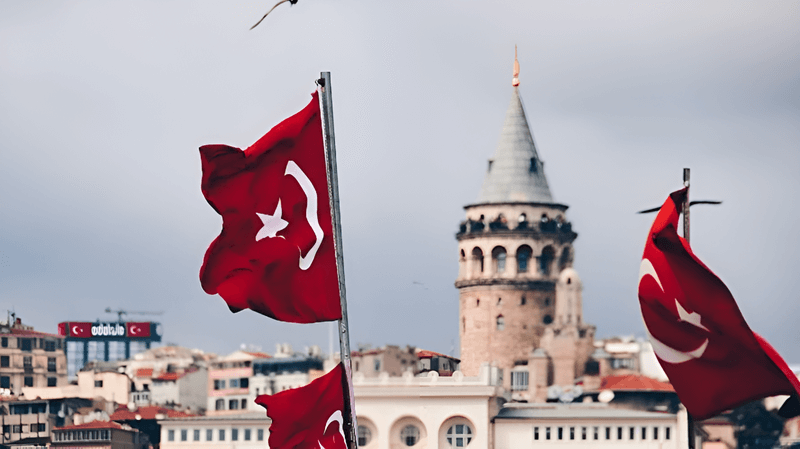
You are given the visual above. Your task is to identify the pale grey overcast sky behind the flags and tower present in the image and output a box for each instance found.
[0,0,800,363]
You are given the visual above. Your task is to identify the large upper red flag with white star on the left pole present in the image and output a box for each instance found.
[200,92,342,323]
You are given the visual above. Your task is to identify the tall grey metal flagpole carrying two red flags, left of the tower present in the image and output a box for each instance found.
[317,72,358,449]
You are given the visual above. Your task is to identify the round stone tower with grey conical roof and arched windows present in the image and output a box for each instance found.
[455,54,595,401]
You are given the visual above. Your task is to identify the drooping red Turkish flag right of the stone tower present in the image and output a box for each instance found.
[639,189,800,419]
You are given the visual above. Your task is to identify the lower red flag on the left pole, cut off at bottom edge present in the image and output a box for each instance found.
[256,363,347,449]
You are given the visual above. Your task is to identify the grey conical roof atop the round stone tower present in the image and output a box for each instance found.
[478,84,553,204]
